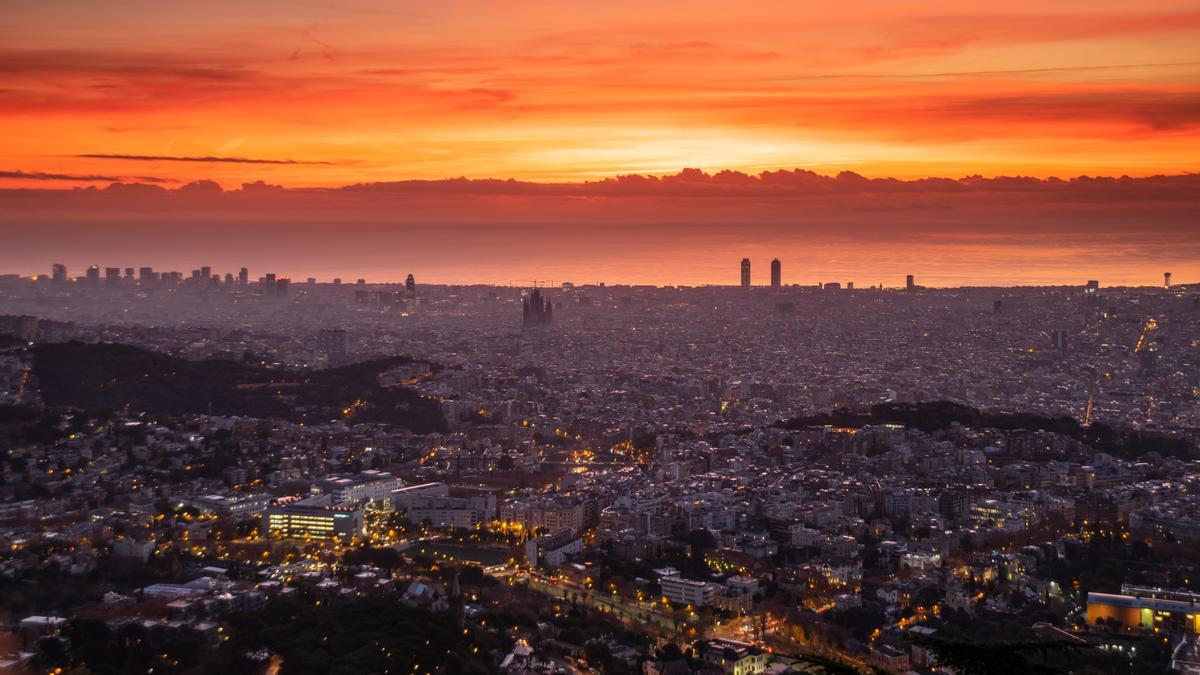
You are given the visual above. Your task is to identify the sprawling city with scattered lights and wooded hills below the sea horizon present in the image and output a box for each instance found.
[0,257,1200,675]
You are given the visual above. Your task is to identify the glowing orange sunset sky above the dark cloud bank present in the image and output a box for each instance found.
[0,0,1200,187]
